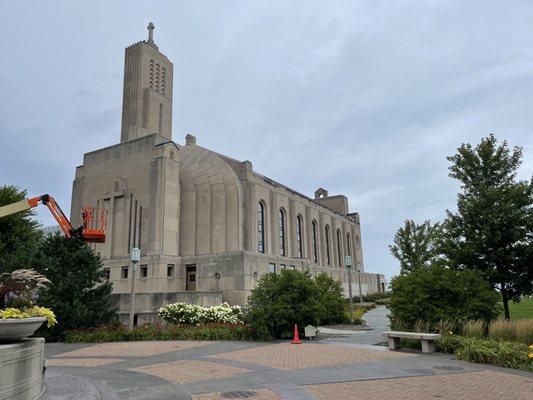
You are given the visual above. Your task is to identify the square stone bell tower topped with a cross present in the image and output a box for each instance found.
[120,22,173,143]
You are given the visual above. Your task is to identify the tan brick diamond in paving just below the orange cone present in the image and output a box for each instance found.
[211,343,412,370]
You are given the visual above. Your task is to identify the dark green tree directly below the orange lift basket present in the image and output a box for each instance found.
[33,234,114,340]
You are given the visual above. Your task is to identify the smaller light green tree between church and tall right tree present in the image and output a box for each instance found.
[389,220,440,274]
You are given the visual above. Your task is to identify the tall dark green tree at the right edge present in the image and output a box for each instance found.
[442,135,533,319]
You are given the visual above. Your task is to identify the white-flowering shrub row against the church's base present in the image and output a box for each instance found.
[158,302,243,325]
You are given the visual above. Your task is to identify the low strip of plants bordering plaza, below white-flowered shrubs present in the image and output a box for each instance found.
[65,324,257,343]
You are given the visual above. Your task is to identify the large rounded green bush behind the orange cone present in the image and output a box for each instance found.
[246,269,346,339]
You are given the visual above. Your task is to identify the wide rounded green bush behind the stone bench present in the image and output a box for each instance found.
[390,265,500,328]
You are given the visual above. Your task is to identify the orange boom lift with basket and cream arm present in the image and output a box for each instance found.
[0,194,106,243]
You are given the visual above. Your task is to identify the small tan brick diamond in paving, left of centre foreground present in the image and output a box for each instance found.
[130,360,251,383]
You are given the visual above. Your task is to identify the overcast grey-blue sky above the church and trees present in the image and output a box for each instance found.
[0,0,533,278]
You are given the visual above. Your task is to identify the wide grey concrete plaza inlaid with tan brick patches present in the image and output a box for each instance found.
[45,334,533,400]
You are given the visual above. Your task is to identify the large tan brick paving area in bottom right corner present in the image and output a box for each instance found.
[303,371,533,400]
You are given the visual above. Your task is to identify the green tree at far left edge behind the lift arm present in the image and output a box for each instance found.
[0,185,42,273]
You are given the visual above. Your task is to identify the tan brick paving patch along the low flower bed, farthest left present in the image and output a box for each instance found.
[54,341,213,357]
